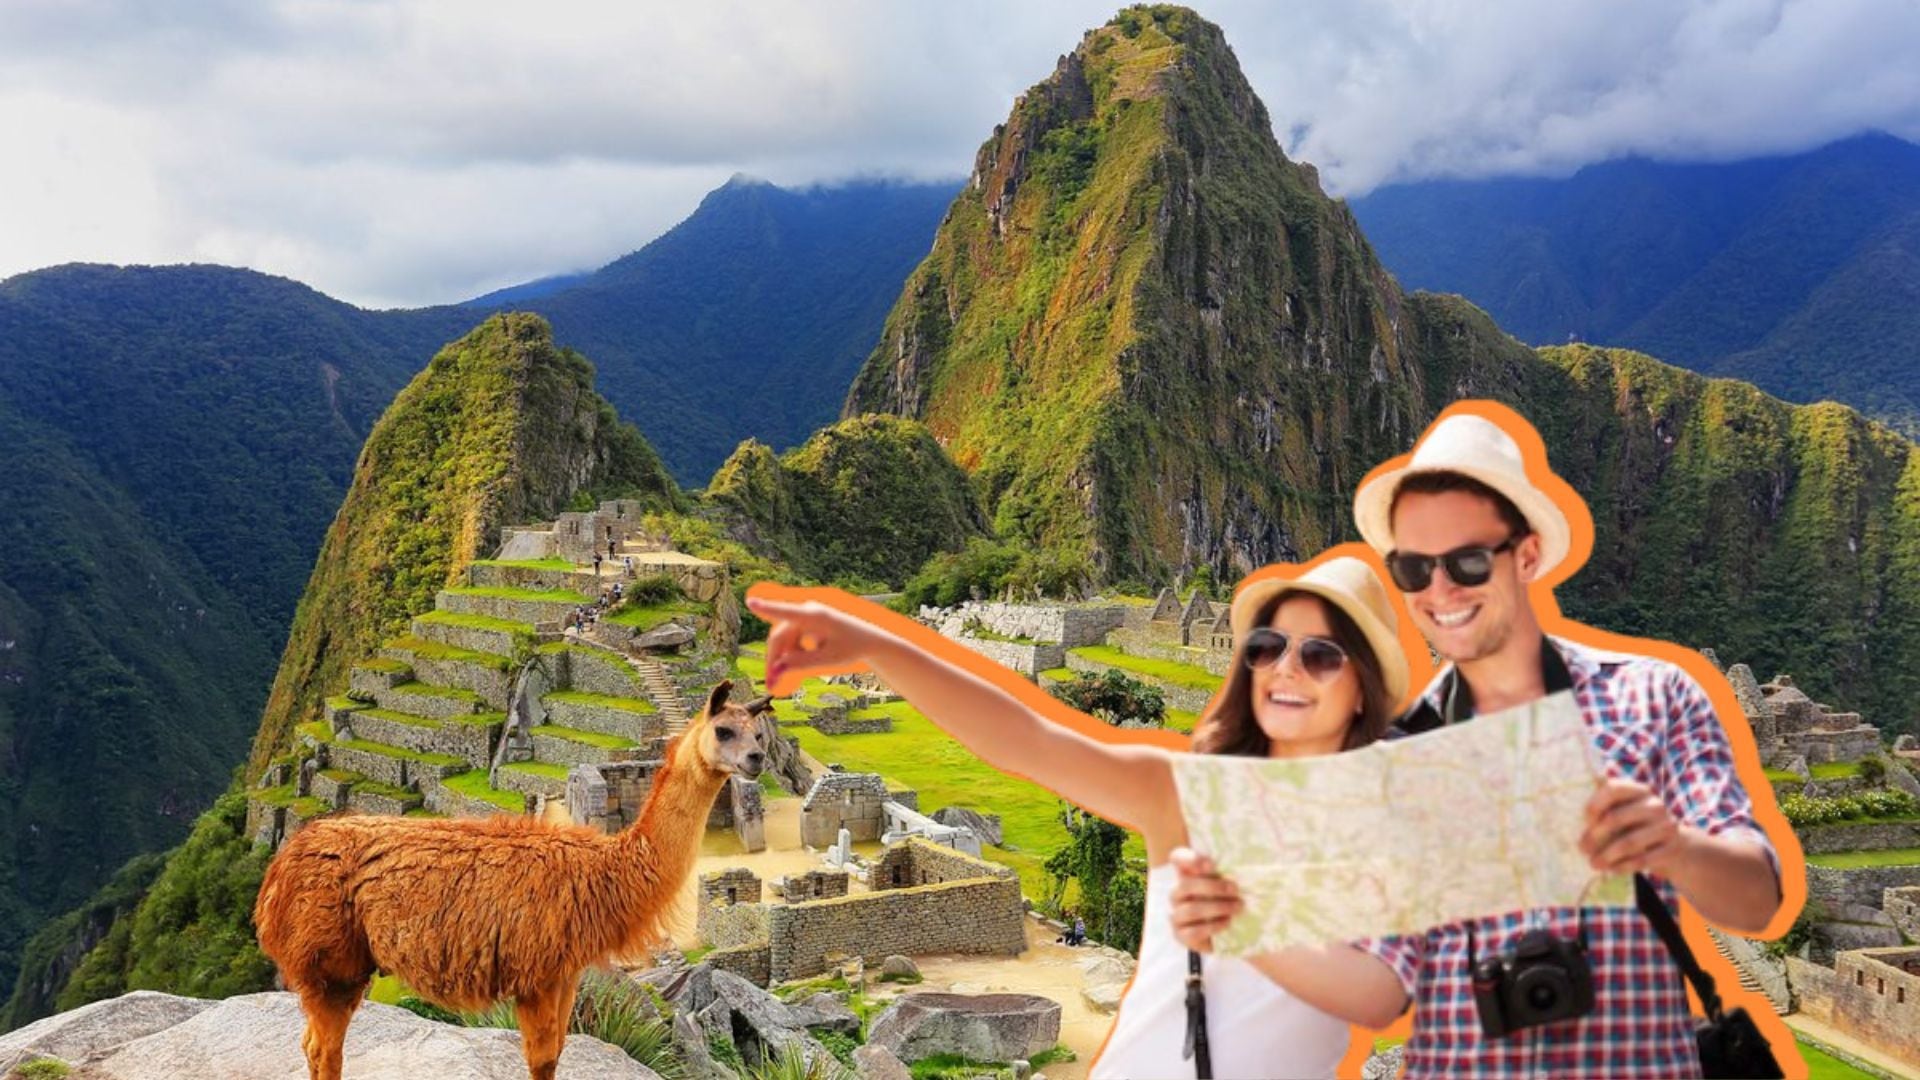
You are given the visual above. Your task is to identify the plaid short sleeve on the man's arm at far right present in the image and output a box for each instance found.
[1661,667,1780,882]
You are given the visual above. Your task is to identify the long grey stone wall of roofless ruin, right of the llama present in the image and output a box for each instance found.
[768,874,1027,982]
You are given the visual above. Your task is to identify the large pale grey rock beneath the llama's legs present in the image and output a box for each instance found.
[15,994,659,1080]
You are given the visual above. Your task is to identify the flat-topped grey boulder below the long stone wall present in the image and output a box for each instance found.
[866,994,1060,1063]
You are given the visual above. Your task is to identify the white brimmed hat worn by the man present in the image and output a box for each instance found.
[1354,413,1571,578]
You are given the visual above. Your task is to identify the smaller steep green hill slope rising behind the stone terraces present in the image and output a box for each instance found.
[248,315,680,776]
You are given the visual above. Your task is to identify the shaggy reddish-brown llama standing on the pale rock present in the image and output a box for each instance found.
[253,682,772,1080]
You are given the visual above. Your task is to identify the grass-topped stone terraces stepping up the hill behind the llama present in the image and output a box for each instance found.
[250,563,714,844]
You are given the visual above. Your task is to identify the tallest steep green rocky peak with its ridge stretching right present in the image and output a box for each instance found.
[845,6,1920,724]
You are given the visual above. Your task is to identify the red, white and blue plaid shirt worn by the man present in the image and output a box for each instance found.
[1357,638,1780,1078]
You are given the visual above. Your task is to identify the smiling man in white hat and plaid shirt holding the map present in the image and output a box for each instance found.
[1173,413,1782,1076]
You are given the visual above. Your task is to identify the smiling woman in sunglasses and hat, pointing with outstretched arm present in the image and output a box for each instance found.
[747,555,1407,1078]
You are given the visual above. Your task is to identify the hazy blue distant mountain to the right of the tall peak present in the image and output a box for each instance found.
[1352,135,1920,436]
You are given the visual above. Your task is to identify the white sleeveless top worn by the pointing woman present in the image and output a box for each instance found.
[1091,863,1350,1080]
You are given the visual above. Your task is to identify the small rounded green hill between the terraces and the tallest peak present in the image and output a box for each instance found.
[707,417,985,586]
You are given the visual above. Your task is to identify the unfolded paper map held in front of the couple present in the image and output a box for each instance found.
[1173,694,1632,955]
